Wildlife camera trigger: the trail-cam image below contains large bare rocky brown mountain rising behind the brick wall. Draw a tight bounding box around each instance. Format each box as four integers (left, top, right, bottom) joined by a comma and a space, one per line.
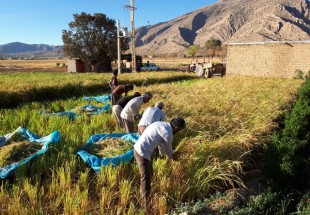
136, 0, 310, 55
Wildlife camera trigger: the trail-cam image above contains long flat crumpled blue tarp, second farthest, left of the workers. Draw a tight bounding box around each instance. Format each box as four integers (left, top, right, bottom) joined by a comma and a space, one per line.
40, 104, 110, 120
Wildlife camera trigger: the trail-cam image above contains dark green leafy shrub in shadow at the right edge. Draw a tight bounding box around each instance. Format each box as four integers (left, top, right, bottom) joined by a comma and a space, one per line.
264, 79, 310, 187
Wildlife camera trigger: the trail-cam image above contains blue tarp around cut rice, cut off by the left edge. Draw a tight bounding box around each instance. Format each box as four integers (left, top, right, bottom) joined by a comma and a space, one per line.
0, 127, 60, 179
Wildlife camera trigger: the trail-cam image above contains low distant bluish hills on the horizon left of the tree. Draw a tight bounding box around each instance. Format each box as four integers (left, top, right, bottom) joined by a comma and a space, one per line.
0, 42, 63, 57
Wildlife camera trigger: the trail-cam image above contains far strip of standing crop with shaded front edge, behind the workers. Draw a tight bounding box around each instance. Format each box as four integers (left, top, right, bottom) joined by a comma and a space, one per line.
0, 72, 196, 108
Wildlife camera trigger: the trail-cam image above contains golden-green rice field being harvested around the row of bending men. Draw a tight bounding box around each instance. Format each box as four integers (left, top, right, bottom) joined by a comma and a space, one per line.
0, 73, 302, 214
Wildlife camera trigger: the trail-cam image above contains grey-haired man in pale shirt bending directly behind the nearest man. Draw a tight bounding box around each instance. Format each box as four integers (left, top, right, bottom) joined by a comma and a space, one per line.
138, 102, 166, 135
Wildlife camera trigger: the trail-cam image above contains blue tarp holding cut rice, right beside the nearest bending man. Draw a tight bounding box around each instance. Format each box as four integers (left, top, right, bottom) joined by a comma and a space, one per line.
77, 133, 140, 172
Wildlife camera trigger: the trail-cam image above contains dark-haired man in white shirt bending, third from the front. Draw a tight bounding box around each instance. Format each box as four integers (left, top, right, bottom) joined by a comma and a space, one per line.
121, 92, 153, 133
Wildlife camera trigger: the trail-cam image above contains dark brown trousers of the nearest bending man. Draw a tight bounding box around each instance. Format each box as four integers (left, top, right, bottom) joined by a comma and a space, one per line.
134, 150, 153, 211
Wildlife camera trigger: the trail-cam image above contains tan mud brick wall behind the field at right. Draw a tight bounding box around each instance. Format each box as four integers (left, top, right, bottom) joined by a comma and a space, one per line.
226, 41, 310, 77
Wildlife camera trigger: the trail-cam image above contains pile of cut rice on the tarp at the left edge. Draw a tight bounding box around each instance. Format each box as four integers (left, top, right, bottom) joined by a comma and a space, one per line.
0, 140, 42, 167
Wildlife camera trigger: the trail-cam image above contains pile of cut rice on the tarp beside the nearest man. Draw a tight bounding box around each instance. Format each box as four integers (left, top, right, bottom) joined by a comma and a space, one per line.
87, 138, 133, 158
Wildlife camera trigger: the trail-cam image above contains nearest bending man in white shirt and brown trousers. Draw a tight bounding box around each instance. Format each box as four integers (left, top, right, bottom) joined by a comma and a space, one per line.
134, 117, 186, 212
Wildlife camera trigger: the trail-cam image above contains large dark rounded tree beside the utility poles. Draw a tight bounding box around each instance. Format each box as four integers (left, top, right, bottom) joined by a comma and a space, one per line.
62, 12, 128, 71
